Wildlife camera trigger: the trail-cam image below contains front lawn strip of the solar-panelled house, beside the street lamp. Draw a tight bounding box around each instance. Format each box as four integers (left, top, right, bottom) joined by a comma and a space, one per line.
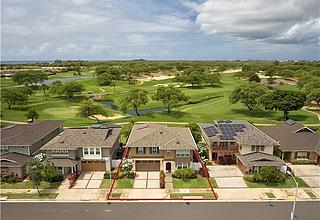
245, 177, 309, 188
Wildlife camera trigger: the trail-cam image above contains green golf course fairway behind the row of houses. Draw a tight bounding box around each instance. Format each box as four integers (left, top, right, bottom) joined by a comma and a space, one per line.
1, 70, 319, 127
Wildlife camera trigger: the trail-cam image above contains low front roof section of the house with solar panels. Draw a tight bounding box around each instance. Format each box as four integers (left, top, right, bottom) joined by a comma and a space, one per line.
236, 152, 285, 166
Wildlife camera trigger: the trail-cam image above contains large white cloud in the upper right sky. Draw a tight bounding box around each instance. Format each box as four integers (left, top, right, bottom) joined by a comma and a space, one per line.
191, 0, 319, 44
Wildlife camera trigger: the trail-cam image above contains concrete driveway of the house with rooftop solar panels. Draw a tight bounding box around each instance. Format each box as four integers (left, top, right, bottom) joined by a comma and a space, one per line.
207, 165, 247, 188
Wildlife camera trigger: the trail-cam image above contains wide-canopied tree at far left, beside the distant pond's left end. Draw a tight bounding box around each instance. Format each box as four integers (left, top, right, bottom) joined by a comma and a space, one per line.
12, 71, 48, 88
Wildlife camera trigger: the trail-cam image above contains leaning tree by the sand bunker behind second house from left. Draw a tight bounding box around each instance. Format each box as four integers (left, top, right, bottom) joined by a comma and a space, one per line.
79, 99, 107, 123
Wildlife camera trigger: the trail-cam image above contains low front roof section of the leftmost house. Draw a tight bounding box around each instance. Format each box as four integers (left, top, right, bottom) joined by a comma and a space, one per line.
0, 153, 32, 167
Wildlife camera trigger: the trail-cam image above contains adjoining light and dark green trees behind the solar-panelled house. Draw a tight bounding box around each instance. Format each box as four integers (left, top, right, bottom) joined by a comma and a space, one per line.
229, 82, 307, 120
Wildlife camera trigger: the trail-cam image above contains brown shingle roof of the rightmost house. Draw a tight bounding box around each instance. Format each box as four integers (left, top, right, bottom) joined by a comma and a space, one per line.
259, 120, 320, 152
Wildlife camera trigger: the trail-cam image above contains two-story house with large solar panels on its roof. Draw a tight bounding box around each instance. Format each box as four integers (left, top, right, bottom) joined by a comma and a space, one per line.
199, 120, 285, 173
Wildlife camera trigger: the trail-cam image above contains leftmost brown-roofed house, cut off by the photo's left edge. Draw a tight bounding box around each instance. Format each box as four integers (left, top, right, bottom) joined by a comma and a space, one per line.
0, 120, 63, 178
